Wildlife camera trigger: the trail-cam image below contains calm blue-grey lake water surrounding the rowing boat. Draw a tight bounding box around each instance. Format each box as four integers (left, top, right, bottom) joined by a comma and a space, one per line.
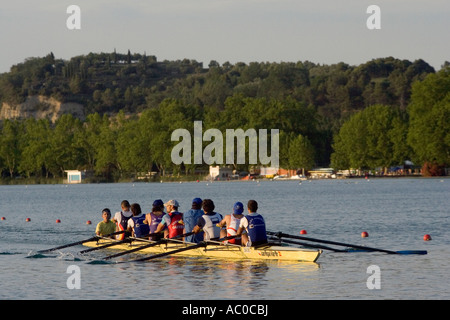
0, 179, 450, 300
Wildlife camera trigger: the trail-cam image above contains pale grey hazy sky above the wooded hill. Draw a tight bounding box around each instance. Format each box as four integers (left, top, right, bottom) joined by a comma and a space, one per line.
0, 0, 450, 73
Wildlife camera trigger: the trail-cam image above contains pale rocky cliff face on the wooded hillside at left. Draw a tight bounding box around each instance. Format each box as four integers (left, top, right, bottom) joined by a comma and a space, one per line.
0, 96, 85, 122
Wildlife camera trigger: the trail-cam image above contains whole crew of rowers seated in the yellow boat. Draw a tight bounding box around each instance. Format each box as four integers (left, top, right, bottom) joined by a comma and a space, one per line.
96, 198, 267, 247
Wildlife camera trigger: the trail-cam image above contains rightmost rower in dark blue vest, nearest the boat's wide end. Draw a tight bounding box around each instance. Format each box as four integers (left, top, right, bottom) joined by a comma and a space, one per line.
237, 200, 267, 247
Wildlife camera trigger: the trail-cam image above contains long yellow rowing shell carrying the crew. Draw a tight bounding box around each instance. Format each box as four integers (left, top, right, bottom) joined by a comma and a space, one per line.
83, 240, 322, 262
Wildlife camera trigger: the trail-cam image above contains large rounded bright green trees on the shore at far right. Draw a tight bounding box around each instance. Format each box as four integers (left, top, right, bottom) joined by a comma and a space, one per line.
331, 66, 450, 174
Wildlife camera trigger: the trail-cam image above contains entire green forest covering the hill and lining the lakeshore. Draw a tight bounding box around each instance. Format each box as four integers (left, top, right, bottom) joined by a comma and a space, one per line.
0, 50, 450, 181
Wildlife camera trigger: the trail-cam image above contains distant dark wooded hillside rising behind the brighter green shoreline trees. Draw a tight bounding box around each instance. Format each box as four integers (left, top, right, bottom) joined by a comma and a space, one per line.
0, 52, 435, 126
